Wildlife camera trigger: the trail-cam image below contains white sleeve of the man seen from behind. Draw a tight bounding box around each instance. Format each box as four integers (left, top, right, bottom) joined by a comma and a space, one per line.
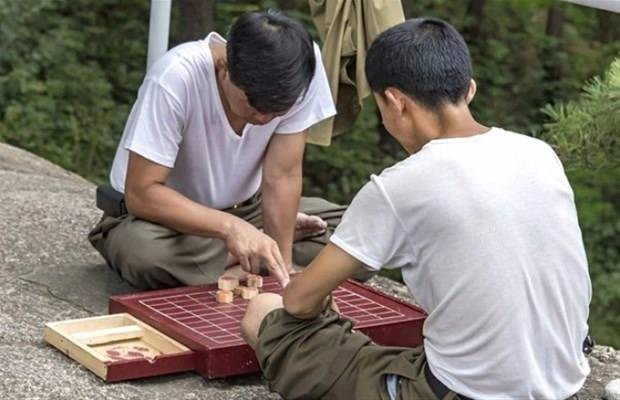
330, 175, 408, 270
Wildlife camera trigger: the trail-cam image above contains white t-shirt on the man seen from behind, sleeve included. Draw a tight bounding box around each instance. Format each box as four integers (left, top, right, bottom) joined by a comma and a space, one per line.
331, 128, 591, 400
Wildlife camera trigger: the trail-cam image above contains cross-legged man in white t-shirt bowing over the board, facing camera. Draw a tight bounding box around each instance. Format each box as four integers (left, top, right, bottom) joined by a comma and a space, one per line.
89, 12, 344, 288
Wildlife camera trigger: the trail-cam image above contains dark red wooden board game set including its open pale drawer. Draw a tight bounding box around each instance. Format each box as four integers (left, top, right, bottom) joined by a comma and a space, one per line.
44, 277, 425, 382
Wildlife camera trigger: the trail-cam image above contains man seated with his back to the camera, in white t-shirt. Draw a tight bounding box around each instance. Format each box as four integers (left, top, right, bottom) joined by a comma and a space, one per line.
241, 19, 591, 399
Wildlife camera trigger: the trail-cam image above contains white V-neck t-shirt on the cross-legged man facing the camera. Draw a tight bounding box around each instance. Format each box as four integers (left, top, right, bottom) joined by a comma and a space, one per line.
110, 32, 336, 209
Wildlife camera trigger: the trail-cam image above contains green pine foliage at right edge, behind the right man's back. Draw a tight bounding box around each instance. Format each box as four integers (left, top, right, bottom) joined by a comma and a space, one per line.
542, 59, 620, 347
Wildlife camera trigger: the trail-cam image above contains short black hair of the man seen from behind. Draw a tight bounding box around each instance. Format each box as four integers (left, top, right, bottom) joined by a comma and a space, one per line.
366, 18, 472, 110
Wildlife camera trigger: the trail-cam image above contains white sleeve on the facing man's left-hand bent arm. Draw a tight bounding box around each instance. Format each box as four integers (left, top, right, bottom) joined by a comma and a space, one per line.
123, 79, 184, 168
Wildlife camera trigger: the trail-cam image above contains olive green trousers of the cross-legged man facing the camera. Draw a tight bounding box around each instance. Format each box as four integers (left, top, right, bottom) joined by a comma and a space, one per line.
88, 196, 346, 289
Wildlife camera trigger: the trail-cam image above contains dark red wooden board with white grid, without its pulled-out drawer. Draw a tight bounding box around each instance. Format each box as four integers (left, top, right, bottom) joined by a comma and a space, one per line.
109, 277, 425, 378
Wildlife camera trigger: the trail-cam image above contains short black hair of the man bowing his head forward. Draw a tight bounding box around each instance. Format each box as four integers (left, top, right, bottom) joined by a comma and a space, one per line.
226, 10, 316, 113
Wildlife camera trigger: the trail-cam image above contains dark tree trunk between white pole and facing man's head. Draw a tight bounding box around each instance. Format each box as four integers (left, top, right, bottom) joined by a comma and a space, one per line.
174, 0, 215, 43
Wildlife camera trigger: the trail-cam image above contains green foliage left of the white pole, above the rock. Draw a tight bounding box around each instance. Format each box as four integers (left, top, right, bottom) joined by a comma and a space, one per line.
0, 0, 148, 181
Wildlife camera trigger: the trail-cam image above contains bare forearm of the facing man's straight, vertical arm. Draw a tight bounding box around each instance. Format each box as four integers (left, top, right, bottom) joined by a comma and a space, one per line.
262, 174, 302, 266
